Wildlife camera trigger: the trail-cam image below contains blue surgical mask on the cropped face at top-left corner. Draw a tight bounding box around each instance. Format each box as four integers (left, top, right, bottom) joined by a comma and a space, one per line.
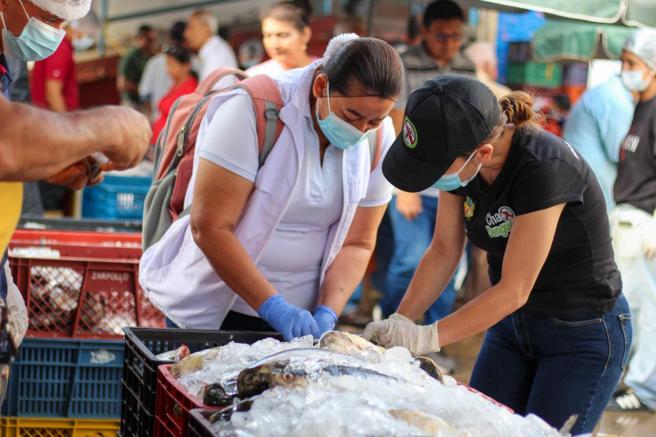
0, 0, 66, 61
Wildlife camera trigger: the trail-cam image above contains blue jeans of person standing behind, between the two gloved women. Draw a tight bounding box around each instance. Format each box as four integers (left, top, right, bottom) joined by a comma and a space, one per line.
380, 196, 456, 324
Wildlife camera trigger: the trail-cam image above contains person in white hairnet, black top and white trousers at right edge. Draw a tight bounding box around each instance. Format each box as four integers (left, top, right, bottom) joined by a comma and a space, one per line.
609, 29, 656, 411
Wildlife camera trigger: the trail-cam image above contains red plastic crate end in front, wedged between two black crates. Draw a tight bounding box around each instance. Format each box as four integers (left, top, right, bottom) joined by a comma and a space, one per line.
154, 364, 218, 437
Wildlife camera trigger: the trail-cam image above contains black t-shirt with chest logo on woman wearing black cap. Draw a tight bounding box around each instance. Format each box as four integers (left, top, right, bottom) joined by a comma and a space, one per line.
453, 127, 622, 318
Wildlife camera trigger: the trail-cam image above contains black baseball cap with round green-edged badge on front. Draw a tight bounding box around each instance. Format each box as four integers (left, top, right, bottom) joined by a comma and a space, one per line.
383, 74, 501, 192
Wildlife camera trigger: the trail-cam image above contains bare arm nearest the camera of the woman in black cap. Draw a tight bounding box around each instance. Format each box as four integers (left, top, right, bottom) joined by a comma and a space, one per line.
426, 204, 565, 346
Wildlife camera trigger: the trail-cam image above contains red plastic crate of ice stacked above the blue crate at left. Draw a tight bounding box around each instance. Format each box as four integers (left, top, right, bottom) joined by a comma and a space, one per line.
9, 230, 164, 338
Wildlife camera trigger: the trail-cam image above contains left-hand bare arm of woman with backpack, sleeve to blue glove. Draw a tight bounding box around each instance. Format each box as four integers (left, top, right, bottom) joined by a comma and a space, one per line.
191, 159, 276, 309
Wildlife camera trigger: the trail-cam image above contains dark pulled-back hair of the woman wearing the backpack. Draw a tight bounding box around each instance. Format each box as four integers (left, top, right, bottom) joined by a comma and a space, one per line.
323, 38, 403, 99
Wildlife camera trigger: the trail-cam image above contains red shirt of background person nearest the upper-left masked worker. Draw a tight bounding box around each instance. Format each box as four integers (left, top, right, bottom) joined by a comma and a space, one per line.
30, 38, 80, 111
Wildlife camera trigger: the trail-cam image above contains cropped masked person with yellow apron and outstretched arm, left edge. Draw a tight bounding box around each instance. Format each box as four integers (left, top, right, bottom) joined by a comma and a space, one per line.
0, 0, 150, 404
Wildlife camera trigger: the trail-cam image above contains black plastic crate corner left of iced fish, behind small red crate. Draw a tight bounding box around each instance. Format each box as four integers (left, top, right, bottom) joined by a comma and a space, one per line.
121, 328, 281, 437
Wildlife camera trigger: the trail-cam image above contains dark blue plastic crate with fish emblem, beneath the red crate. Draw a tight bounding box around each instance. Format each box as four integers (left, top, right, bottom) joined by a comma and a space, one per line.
2, 338, 124, 419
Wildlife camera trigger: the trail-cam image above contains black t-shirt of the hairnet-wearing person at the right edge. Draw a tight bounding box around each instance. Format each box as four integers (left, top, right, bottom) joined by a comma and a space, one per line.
614, 98, 656, 214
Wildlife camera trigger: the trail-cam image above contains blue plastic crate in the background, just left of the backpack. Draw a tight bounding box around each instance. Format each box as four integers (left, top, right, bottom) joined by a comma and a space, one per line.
82, 175, 151, 220
